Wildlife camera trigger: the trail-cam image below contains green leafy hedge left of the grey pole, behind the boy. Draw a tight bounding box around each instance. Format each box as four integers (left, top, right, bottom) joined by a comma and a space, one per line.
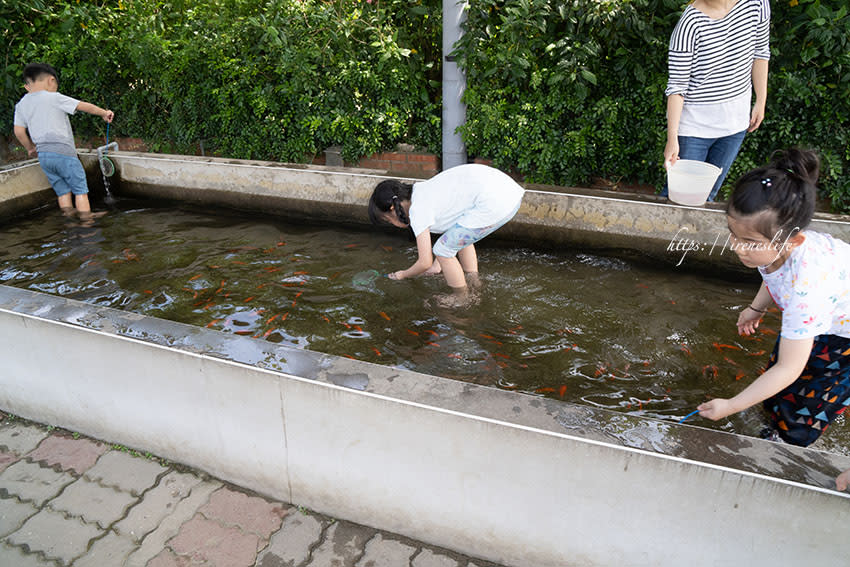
0, 0, 441, 161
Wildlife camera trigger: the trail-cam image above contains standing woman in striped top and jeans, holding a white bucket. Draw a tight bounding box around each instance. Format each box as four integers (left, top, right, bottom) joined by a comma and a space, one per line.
662, 0, 770, 201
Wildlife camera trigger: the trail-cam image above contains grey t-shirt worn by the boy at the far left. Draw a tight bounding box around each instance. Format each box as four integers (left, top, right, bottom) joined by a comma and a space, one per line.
15, 91, 80, 156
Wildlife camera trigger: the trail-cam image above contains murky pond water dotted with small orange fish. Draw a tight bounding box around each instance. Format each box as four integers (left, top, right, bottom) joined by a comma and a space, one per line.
0, 199, 850, 453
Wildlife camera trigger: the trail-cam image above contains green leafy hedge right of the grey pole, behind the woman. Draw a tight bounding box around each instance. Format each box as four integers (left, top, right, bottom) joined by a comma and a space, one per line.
456, 0, 850, 212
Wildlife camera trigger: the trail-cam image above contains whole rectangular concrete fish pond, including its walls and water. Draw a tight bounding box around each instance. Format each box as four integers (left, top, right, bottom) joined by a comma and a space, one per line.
0, 152, 850, 566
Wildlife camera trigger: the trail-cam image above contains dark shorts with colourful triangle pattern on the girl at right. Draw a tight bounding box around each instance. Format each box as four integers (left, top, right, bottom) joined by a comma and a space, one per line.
764, 335, 850, 447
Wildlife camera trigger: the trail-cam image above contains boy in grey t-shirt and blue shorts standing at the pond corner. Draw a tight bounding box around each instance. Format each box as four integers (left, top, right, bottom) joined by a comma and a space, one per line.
15, 63, 114, 219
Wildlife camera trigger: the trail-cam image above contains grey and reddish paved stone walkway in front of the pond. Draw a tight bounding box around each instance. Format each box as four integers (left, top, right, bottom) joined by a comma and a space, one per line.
0, 413, 504, 567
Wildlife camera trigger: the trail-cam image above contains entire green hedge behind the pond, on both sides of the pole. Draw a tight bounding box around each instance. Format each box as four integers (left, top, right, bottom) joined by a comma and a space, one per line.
0, 0, 850, 212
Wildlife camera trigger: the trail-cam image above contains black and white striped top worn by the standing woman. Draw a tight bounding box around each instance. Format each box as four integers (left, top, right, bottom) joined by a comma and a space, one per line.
665, 0, 770, 105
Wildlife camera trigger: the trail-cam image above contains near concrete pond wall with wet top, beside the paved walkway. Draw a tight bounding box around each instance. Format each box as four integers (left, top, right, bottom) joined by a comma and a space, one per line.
0, 286, 850, 567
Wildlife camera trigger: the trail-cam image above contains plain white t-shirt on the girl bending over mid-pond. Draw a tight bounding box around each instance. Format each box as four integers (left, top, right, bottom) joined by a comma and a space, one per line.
409, 163, 525, 236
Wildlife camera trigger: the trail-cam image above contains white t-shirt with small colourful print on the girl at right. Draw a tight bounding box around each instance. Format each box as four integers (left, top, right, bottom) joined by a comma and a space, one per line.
759, 231, 850, 339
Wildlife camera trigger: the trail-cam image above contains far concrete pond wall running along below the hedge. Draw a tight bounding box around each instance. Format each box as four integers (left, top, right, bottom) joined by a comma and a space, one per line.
73, 152, 850, 273
